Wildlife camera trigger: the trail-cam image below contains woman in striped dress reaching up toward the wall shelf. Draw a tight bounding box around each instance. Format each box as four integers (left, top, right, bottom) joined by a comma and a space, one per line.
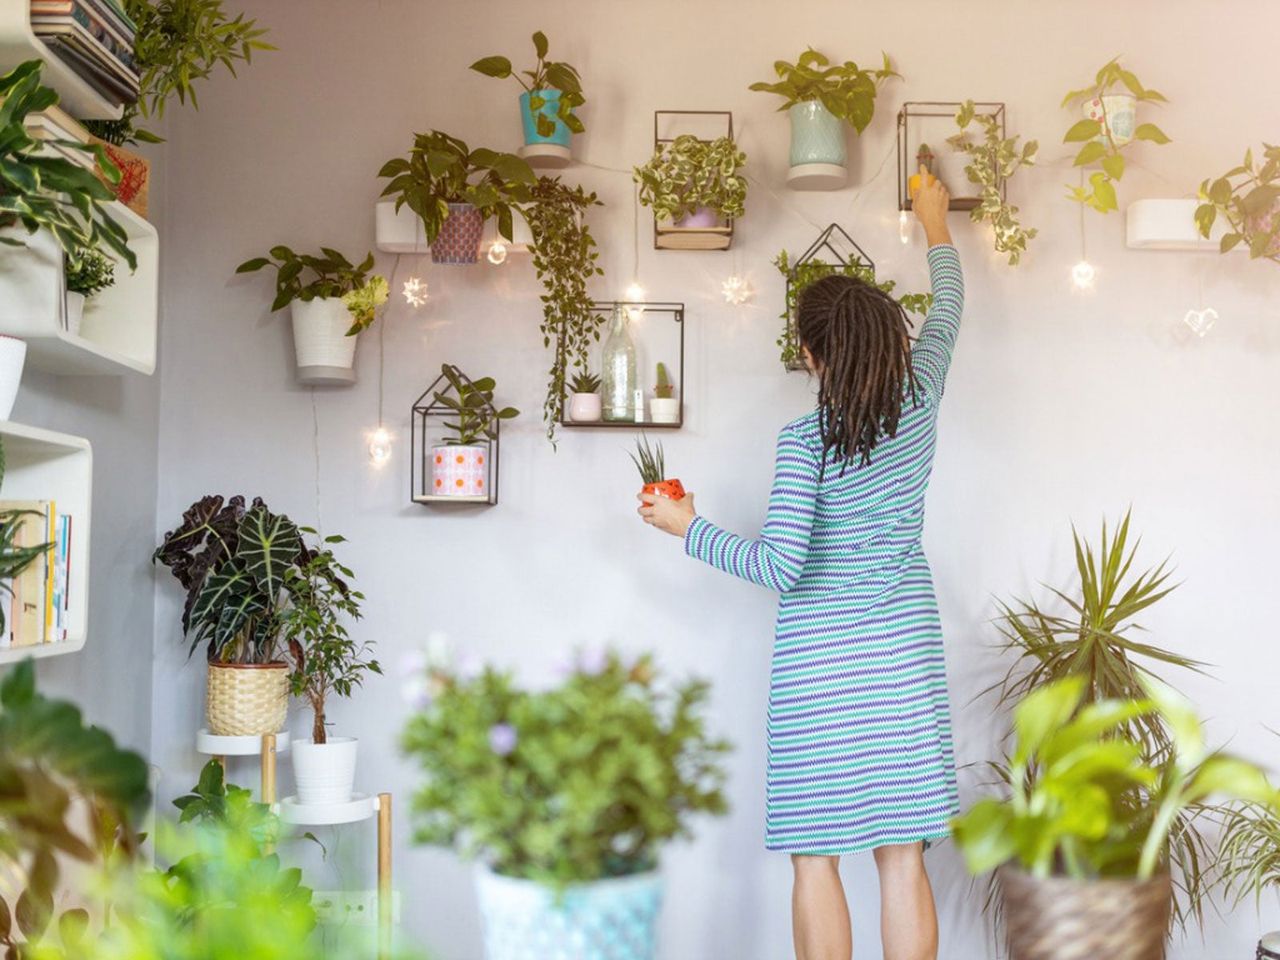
640, 178, 964, 960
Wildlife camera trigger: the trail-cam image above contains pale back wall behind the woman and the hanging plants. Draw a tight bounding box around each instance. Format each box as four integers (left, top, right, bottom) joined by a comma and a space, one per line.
147, 0, 1280, 960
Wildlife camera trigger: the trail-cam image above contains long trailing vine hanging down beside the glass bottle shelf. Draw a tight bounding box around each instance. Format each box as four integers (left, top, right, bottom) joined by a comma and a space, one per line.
525, 177, 604, 447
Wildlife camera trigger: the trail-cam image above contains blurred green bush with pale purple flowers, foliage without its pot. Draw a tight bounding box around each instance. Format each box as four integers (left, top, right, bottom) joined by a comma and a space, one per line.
403, 653, 730, 887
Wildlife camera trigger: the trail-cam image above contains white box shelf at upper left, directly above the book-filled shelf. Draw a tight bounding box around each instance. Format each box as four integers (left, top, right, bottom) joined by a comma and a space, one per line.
0, 200, 160, 375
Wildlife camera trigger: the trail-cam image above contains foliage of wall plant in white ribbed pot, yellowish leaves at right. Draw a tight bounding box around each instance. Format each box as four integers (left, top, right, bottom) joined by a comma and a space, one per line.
236, 244, 389, 337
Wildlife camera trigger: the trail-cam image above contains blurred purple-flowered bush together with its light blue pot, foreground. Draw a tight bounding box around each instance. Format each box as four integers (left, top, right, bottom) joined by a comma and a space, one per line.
403, 652, 728, 960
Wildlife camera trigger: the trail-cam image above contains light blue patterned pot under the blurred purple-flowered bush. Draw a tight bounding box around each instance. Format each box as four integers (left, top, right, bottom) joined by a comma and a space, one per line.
476, 867, 662, 960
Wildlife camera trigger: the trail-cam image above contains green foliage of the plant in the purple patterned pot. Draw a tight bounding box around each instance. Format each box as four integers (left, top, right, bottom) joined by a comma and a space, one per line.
378, 131, 538, 243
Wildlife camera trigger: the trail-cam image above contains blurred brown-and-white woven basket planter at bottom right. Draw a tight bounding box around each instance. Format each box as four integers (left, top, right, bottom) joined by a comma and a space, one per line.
998, 867, 1172, 960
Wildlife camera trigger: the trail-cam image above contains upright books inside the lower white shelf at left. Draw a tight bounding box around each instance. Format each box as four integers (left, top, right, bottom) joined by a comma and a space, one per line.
0, 500, 72, 649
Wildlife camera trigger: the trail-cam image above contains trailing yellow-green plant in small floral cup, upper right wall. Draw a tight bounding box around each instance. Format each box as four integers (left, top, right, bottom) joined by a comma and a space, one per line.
1062, 58, 1169, 214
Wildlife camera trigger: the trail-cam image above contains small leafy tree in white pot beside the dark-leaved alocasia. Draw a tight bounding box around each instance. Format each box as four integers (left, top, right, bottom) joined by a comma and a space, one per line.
280, 537, 383, 804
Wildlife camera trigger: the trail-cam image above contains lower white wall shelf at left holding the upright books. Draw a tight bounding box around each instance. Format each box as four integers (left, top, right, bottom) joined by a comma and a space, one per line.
0, 420, 93, 663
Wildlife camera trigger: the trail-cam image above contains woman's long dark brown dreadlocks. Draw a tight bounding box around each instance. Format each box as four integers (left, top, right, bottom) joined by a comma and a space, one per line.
796, 275, 916, 474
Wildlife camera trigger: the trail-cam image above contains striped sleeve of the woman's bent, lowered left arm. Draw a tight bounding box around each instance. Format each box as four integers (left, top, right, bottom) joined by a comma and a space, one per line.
685, 428, 818, 593
